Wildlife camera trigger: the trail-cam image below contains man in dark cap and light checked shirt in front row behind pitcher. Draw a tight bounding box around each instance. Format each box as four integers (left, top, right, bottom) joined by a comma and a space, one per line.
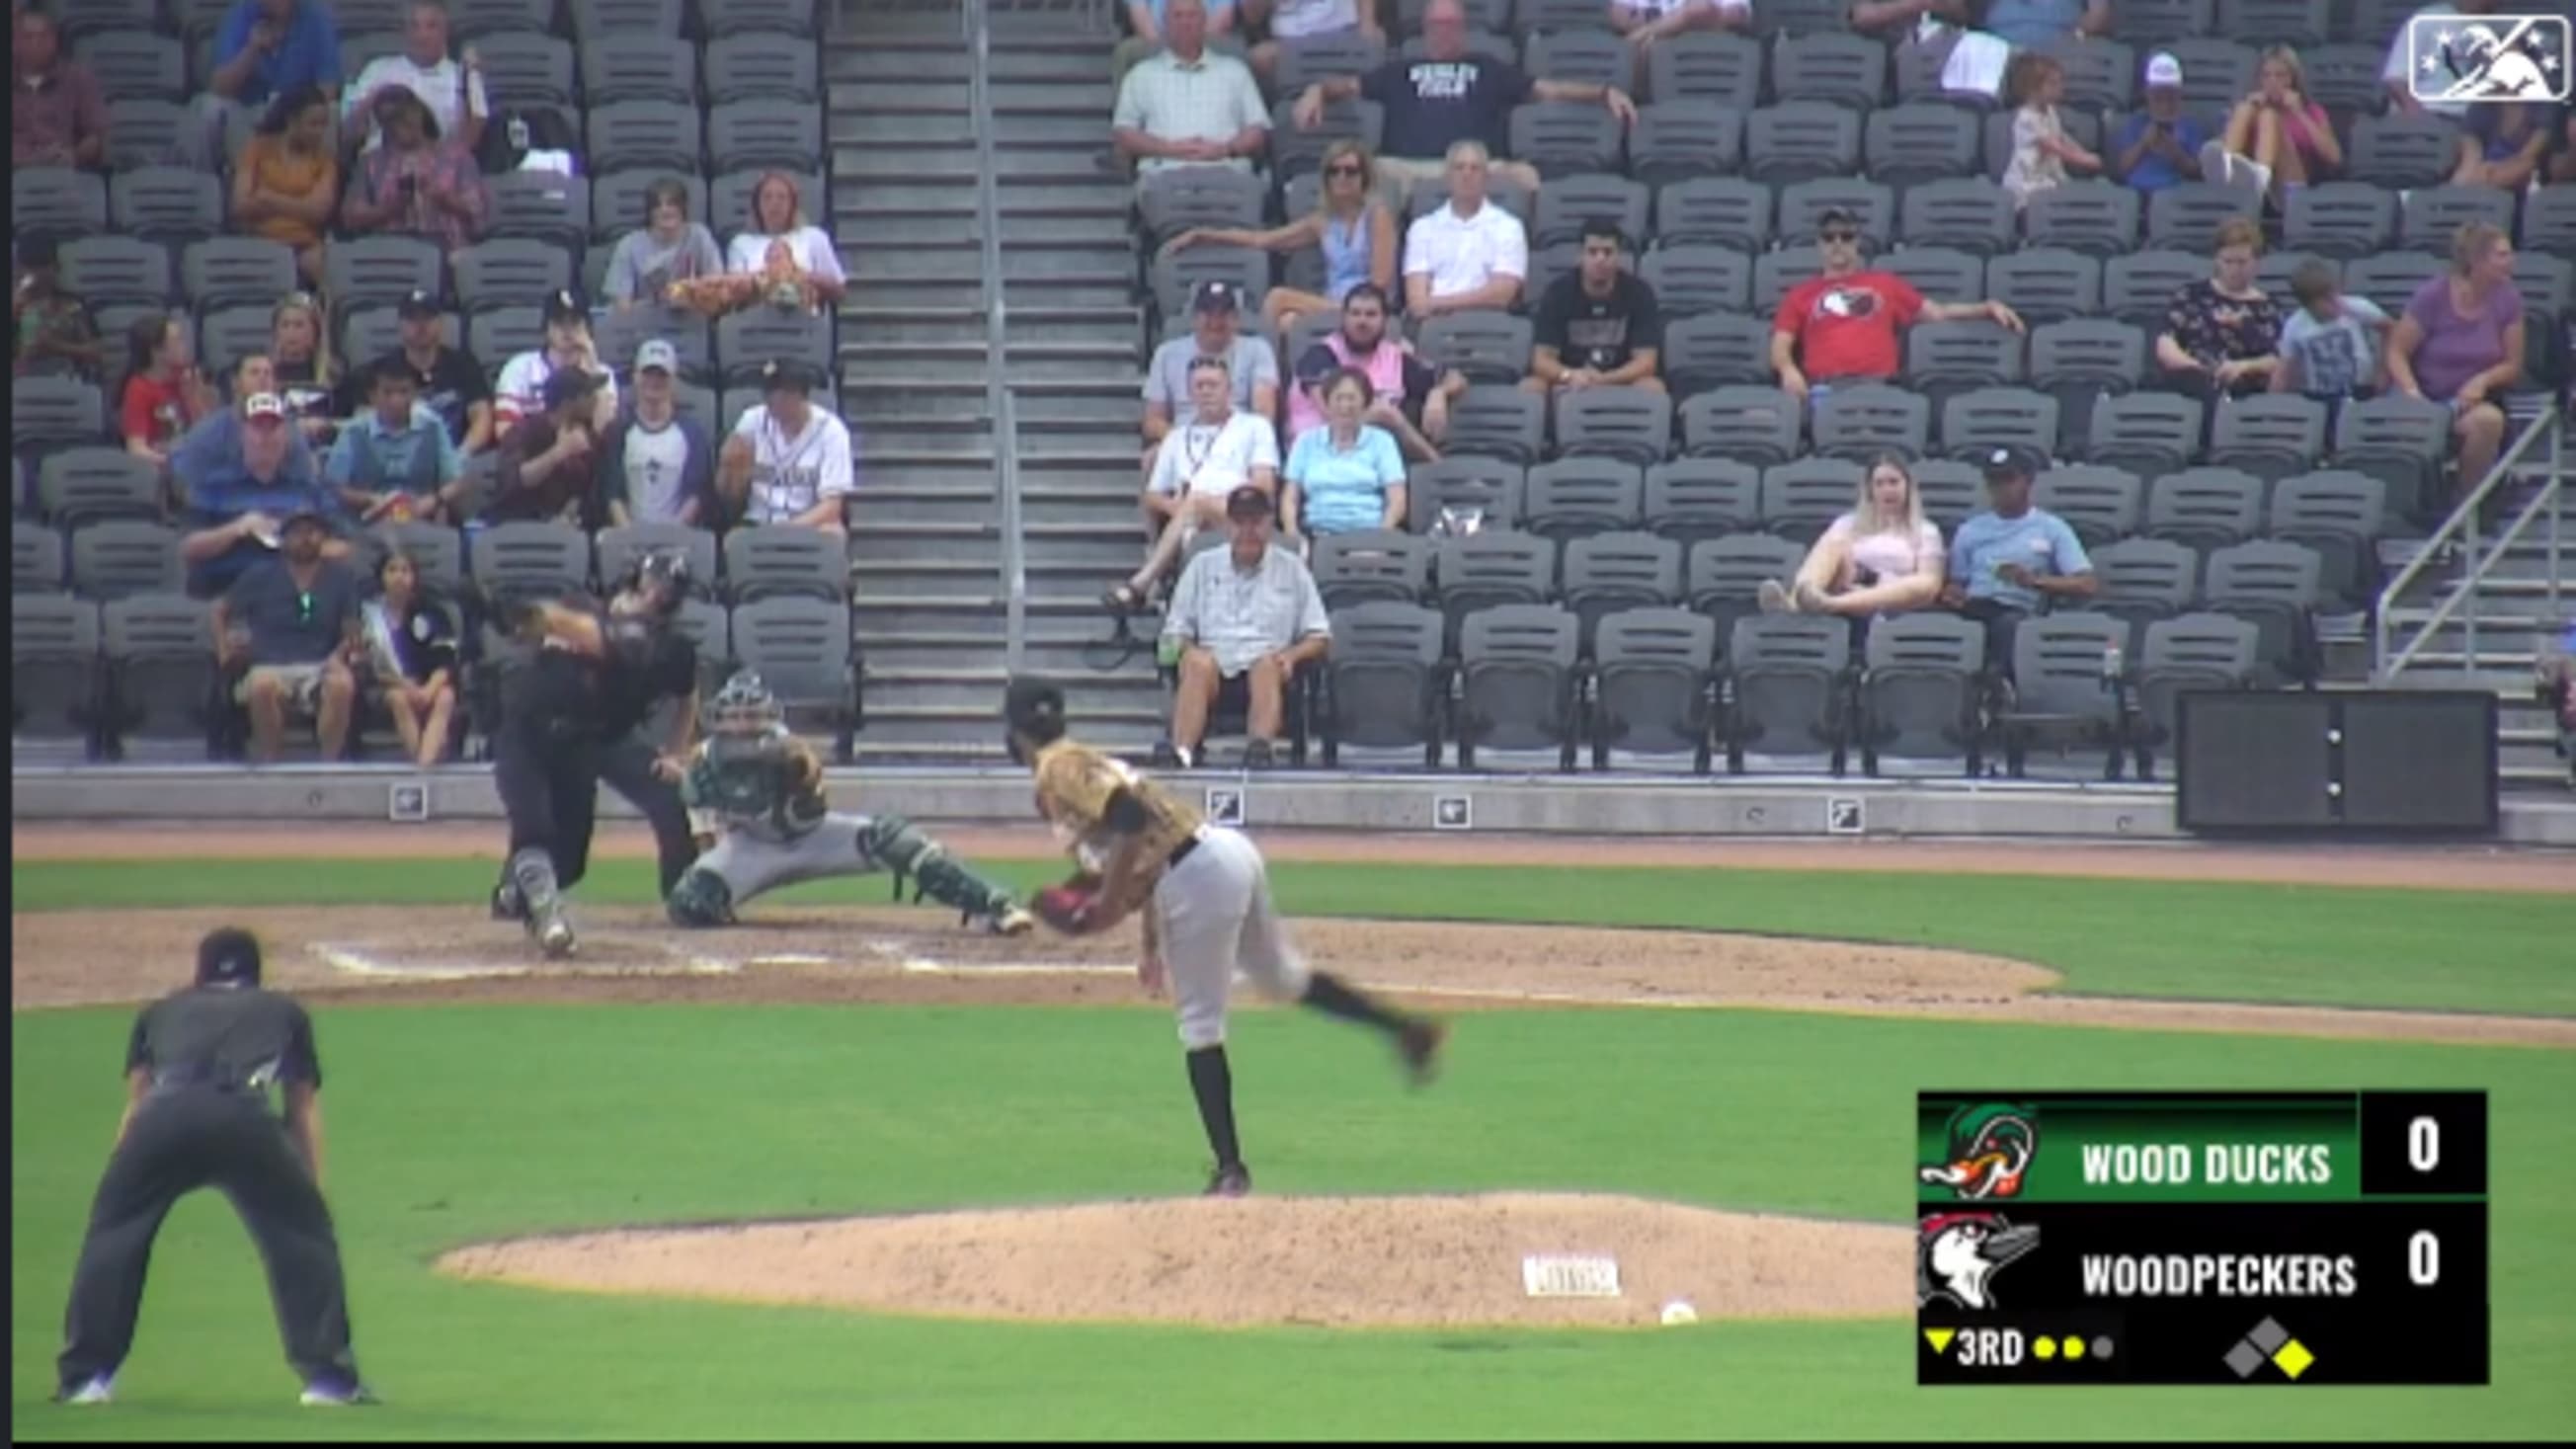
1157, 482, 1331, 768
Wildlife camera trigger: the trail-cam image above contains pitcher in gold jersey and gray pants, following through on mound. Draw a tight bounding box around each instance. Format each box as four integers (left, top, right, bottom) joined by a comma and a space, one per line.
1003, 679, 1448, 1196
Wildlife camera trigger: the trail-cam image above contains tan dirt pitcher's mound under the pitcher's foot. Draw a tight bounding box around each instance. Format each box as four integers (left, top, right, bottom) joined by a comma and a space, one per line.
438, 1194, 1914, 1328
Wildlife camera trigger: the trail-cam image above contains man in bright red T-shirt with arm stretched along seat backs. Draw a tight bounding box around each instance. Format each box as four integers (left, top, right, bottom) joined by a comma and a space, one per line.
1772, 206, 2022, 402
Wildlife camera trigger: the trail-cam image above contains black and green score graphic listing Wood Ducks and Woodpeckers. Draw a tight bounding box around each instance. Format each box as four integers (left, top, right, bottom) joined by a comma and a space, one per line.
1914, 1090, 2488, 1387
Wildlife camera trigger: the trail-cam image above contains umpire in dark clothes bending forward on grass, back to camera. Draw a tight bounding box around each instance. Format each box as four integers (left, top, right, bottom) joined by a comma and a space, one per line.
54, 928, 371, 1406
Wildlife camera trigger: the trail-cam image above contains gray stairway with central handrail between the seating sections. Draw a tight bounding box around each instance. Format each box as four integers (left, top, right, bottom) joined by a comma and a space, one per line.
825, 5, 1160, 758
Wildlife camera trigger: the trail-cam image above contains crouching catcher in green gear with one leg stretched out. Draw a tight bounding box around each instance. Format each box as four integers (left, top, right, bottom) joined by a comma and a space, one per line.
667, 671, 1035, 936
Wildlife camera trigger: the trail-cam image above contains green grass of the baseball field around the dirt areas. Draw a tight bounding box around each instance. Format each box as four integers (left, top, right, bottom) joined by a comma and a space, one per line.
10, 861, 2576, 1441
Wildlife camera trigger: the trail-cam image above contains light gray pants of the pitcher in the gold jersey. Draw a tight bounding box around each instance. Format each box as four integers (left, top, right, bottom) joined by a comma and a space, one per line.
1152, 825, 1306, 1052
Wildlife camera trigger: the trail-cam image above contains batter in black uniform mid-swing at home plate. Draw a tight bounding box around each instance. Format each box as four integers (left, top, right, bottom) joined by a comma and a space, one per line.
492, 552, 698, 956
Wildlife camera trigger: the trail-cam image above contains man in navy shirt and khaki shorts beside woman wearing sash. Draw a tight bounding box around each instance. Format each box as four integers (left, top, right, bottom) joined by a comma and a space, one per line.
213, 495, 365, 764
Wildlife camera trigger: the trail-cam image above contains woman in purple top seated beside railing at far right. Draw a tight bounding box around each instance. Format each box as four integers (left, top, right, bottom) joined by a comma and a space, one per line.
2388, 221, 2525, 503
